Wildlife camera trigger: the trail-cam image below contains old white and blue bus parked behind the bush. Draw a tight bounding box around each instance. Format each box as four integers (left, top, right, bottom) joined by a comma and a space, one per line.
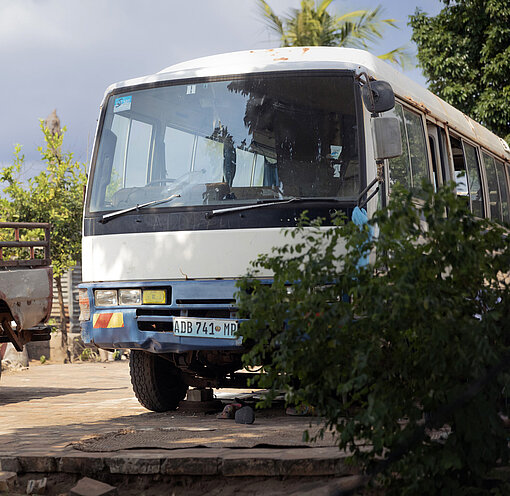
80, 47, 510, 411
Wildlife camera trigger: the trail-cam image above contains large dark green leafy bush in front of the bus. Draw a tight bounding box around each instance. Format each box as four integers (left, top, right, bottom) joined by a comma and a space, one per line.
238, 184, 510, 496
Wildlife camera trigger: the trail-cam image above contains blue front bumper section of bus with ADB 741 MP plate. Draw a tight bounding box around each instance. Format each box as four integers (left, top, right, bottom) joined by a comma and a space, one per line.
79, 280, 247, 353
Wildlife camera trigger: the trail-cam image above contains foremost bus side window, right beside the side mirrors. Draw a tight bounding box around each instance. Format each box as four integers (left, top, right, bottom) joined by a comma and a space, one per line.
389, 103, 429, 195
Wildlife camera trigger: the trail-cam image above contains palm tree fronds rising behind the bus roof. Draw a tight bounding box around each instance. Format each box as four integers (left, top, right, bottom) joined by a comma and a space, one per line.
258, 0, 409, 66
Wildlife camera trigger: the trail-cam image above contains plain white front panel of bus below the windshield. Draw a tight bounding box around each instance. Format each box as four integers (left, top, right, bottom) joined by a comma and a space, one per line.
83, 228, 291, 282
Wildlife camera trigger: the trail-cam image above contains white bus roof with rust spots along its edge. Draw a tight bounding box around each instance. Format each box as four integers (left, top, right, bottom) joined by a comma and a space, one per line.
106, 47, 510, 160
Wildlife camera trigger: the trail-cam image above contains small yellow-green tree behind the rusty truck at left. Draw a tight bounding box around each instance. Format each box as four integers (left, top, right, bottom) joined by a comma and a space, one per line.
0, 121, 86, 347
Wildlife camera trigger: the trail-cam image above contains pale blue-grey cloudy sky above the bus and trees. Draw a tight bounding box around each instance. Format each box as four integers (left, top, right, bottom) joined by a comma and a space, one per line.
0, 0, 442, 177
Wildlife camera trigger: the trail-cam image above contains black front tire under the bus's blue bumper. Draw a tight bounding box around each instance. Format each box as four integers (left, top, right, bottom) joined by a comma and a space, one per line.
129, 350, 188, 412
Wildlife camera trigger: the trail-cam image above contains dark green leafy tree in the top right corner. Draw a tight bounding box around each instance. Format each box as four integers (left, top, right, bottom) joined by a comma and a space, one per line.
409, 0, 510, 143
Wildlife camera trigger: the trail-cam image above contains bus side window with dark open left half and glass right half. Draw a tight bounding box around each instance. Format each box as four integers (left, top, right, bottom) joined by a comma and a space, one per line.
450, 136, 484, 217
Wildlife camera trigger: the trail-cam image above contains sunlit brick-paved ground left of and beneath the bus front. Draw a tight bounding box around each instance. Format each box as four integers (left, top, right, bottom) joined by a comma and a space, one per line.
0, 360, 331, 453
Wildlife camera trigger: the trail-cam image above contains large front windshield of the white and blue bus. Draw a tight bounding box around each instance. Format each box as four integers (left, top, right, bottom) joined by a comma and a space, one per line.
89, 72, 360, 212
